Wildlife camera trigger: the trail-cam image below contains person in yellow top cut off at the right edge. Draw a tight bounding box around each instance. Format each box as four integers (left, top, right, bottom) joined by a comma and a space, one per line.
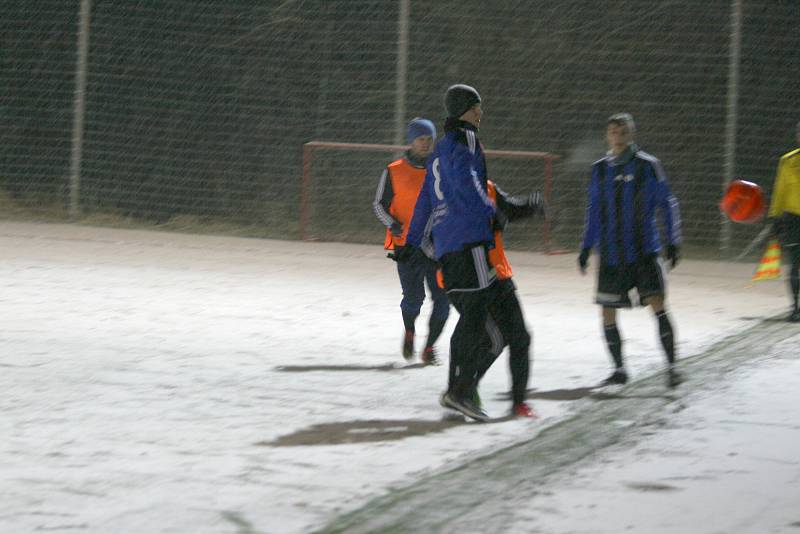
767, 122, 800, 323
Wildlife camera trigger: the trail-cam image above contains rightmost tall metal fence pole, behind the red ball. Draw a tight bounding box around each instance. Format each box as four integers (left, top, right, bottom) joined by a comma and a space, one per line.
719, 0, 742, 259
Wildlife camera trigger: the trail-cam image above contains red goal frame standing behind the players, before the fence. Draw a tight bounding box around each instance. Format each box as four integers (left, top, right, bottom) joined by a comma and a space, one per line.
300, 141, 560, 254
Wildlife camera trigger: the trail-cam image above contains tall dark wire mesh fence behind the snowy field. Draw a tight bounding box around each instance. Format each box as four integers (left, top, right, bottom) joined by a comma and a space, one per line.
0, 0, 800, 255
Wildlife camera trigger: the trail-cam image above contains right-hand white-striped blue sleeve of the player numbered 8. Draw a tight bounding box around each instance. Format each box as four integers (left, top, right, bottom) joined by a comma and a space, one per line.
453, 140, 495, 220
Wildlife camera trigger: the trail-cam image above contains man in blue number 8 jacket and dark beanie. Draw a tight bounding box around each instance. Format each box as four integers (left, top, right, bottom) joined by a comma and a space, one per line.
401, 84, 497, 420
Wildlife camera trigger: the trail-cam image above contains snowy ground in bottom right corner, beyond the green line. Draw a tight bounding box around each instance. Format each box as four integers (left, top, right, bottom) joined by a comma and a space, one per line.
504, 348, 800, 534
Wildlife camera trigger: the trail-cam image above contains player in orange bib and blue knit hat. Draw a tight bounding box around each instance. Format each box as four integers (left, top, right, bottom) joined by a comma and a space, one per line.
372, 118, 450, 364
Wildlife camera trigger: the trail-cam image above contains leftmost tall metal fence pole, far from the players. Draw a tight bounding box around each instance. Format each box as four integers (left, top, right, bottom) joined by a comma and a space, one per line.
69, 0, 92, 222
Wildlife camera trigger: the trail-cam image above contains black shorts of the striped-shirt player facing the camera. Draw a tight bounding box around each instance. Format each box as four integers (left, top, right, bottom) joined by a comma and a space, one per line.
595, 255, 666, 308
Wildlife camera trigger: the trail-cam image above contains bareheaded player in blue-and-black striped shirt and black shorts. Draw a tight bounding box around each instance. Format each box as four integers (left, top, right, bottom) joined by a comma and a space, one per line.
578, 113, 682, 387
